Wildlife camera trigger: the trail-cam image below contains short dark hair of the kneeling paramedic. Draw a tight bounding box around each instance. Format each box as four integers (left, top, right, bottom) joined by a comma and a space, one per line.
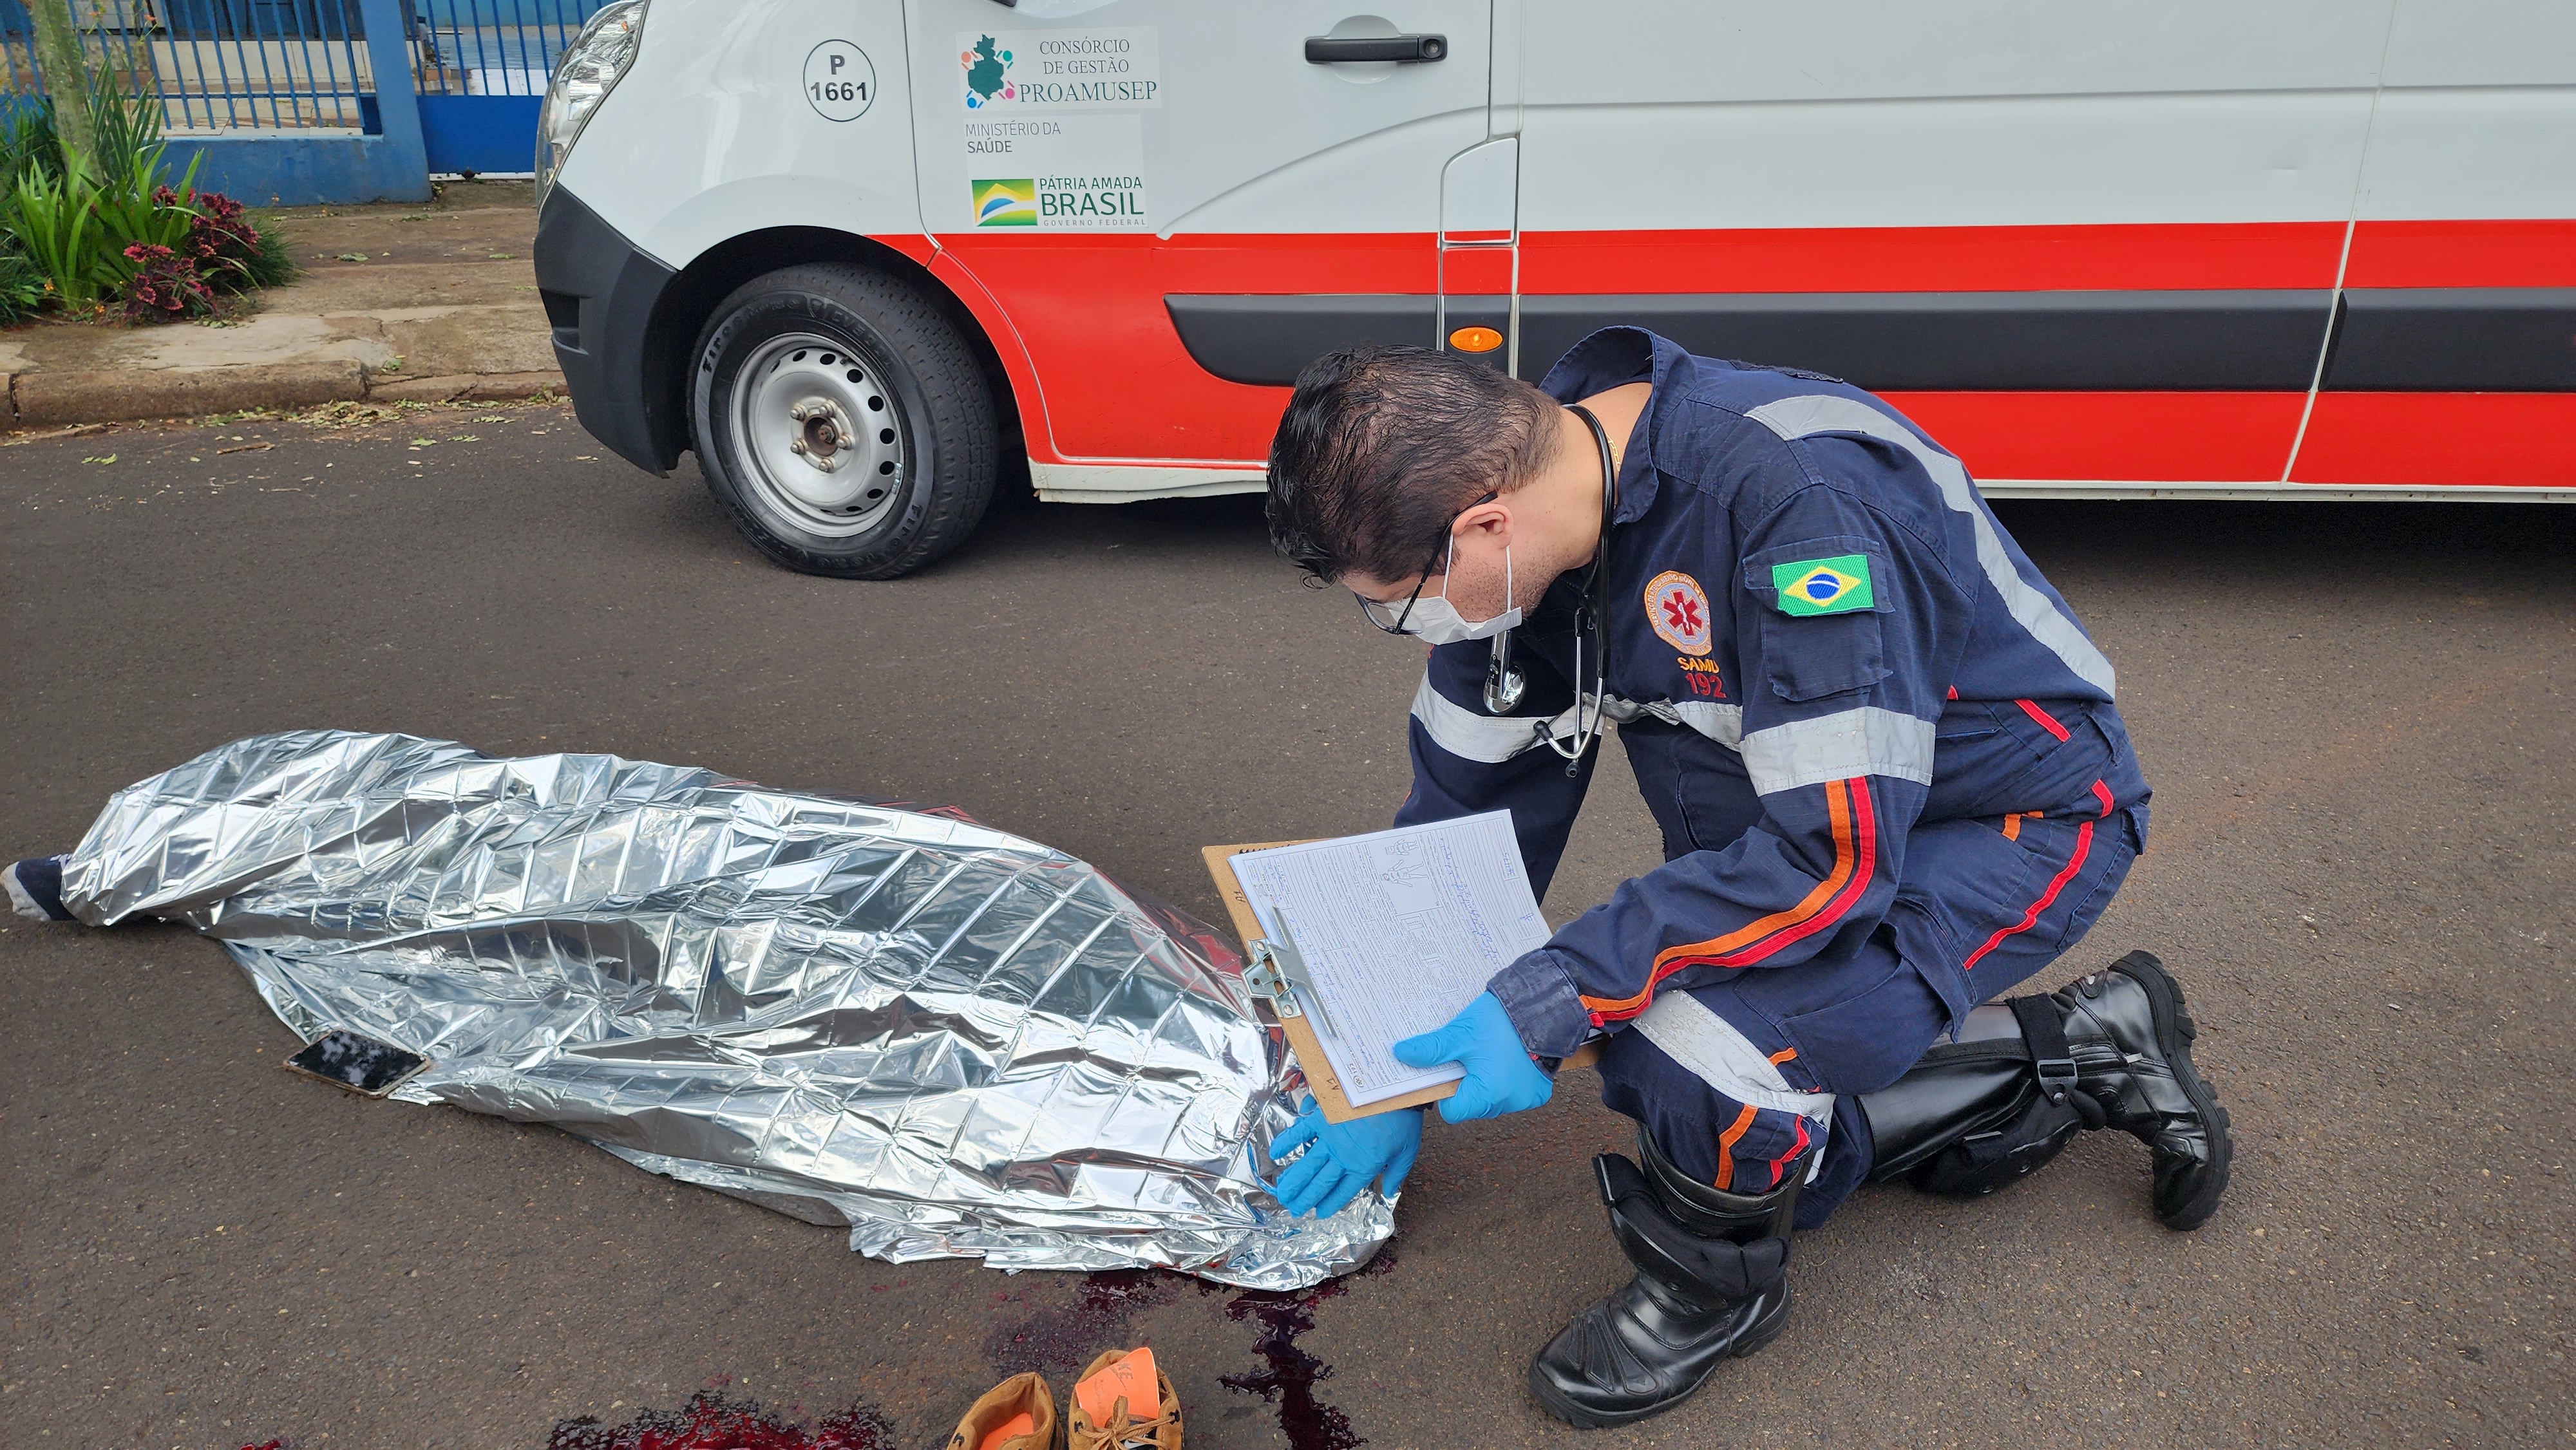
1267, 348, 1556, 582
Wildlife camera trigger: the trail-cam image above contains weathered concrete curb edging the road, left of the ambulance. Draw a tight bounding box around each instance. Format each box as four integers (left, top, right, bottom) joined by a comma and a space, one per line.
0, 358, 564, 430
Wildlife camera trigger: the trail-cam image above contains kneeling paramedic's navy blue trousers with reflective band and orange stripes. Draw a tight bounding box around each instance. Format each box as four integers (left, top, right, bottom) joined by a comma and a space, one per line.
1600, 721, 2146, 1229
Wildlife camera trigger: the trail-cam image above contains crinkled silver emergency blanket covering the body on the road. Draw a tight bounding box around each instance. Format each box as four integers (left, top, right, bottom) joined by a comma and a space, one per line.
62, 731, 1394, 1288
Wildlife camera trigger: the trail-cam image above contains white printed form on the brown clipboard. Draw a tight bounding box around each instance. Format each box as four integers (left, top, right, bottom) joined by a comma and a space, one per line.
1226, 811, 1548, 1107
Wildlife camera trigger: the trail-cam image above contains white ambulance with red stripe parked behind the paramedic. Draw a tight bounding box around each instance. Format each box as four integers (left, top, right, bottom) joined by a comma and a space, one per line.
536, 0, 2576, 577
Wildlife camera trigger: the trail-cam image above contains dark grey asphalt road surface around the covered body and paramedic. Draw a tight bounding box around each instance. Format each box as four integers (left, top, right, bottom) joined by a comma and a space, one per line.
0, 407, 2576, 1450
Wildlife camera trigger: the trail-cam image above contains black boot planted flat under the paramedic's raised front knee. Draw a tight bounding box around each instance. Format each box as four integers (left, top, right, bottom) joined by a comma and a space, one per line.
1530, 1133, 1814, 1429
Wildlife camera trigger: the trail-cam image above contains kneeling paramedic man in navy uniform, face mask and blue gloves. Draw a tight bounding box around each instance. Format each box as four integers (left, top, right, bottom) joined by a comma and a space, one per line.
1270, 327, 2231, 1427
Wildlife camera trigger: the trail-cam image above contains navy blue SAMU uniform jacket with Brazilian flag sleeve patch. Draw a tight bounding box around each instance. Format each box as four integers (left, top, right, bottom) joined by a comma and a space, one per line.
1396, 327, 2146, 1056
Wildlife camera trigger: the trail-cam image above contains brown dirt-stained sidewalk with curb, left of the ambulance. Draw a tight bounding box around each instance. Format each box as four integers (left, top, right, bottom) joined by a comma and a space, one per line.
0, 180, 564, 430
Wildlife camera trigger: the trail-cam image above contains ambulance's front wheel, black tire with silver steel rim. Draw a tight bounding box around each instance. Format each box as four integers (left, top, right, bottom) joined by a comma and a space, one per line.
690, 263, 1002, 579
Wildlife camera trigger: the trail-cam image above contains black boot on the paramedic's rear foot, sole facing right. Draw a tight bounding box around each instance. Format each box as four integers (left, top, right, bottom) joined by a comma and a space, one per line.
1860, 950, 2233, 1229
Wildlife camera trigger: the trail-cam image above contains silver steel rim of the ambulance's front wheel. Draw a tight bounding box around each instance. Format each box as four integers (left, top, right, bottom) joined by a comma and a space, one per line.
732, 332, 909, 538
